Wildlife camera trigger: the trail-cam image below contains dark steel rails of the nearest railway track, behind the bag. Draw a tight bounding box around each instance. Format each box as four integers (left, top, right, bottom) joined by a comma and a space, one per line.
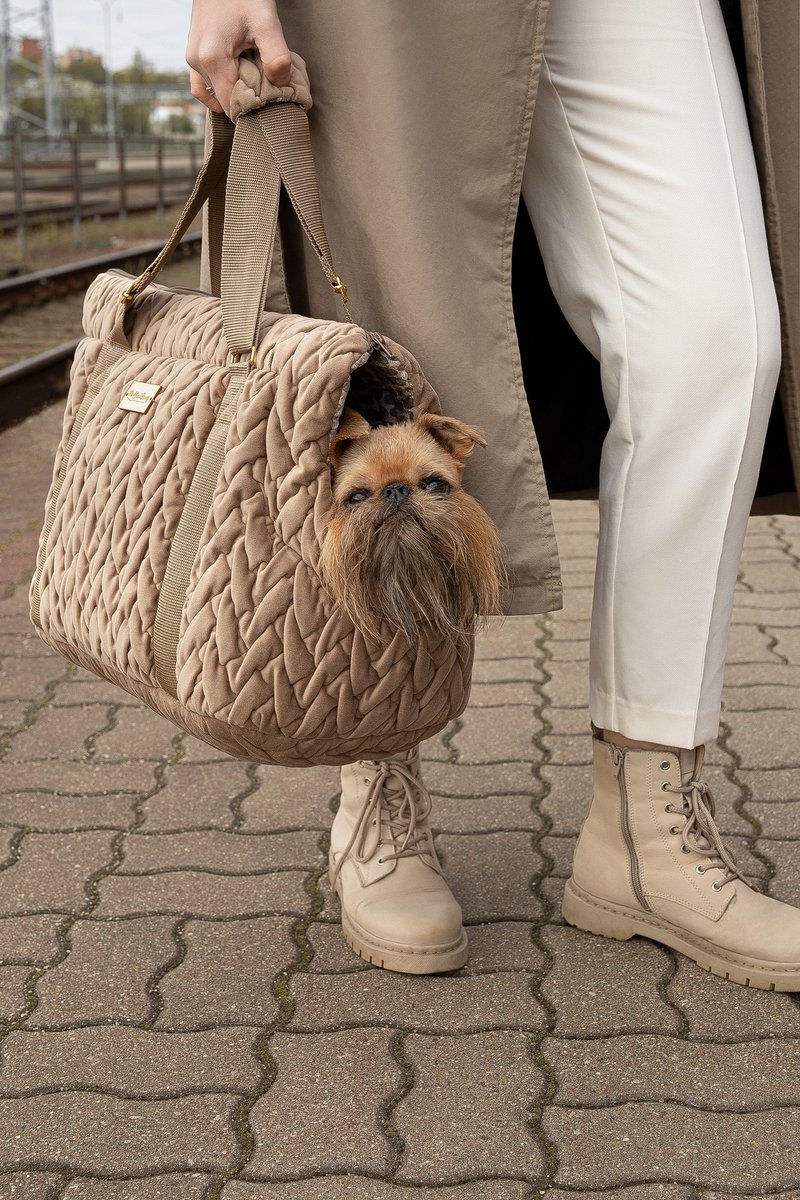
0, 233, 200, 428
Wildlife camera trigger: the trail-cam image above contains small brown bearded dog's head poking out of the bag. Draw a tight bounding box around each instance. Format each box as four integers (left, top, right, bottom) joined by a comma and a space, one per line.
320, 408, 506, 644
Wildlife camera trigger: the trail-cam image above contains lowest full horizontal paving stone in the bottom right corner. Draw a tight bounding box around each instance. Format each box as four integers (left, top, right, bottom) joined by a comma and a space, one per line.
542, 1103, 800, 1188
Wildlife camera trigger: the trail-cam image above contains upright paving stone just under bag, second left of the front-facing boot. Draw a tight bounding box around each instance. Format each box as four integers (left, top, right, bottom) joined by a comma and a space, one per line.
142, 762, 251, 833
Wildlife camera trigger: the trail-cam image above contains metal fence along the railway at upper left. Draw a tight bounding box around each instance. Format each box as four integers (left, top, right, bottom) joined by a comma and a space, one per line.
0, 134, 203, 256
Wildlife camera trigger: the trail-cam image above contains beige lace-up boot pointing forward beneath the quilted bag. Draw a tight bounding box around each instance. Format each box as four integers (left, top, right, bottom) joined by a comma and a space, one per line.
329, 749, 468, 974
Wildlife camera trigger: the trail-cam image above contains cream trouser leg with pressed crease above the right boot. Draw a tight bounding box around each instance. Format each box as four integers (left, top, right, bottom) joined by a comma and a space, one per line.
523, 0, 781, 746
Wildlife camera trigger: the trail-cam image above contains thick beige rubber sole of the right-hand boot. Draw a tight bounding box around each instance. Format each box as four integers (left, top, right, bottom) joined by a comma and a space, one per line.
561, 880, 800, 991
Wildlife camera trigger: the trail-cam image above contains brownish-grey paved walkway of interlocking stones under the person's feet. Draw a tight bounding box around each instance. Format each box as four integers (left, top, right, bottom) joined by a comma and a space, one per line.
0, 410, 800, 1200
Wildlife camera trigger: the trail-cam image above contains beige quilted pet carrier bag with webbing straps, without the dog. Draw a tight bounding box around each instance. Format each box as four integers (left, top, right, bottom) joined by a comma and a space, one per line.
31, 55, 473, 767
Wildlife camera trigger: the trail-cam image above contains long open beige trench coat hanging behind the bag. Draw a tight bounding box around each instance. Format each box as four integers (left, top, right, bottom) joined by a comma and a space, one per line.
201, 0, 800, 613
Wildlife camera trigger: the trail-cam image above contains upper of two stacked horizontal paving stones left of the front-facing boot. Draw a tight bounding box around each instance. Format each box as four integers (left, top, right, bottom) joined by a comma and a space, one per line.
118, 829, 319, 875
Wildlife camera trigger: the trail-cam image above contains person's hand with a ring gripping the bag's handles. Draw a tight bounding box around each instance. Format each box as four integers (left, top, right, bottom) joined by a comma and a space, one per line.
186, 0, 291, 116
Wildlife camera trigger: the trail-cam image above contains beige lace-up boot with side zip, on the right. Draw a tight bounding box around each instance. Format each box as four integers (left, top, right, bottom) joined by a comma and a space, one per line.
563, 736, 800, 991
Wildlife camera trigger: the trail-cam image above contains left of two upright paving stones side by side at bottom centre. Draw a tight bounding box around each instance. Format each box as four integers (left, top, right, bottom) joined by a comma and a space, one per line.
243, 1028, 403, 1181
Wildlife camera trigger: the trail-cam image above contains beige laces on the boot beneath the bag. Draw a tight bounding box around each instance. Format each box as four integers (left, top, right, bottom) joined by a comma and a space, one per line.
331, 760, 443, 884
